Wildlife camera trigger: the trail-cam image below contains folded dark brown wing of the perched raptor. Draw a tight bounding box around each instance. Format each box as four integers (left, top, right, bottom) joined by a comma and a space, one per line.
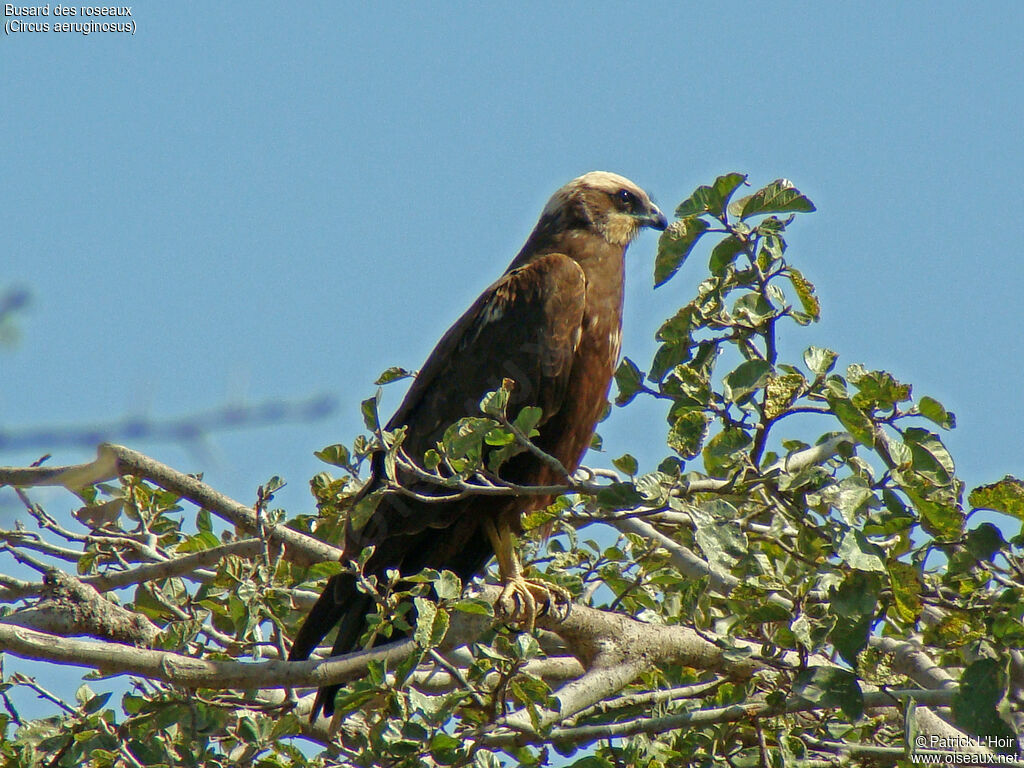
346, 254, 587, 540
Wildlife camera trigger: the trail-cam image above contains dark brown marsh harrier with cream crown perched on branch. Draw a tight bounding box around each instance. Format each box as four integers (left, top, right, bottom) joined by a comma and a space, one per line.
289, 171, 667, 719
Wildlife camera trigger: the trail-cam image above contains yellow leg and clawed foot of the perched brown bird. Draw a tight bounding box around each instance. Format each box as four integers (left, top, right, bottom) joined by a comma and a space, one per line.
483, 519, 572, 632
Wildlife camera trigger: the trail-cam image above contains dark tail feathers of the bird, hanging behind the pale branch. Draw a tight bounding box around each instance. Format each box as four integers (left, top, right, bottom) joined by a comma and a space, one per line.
288, 573, 373, 722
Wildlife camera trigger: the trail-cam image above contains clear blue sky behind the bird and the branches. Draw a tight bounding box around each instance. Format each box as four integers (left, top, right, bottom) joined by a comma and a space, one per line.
0, 1, 1024, 733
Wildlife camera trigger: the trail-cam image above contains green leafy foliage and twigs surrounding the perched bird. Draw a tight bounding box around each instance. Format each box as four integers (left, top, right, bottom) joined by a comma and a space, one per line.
0, 173, 1024, 768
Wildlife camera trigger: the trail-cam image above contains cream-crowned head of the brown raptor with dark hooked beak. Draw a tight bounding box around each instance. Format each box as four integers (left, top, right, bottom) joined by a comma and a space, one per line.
541, 171, 669, 248
